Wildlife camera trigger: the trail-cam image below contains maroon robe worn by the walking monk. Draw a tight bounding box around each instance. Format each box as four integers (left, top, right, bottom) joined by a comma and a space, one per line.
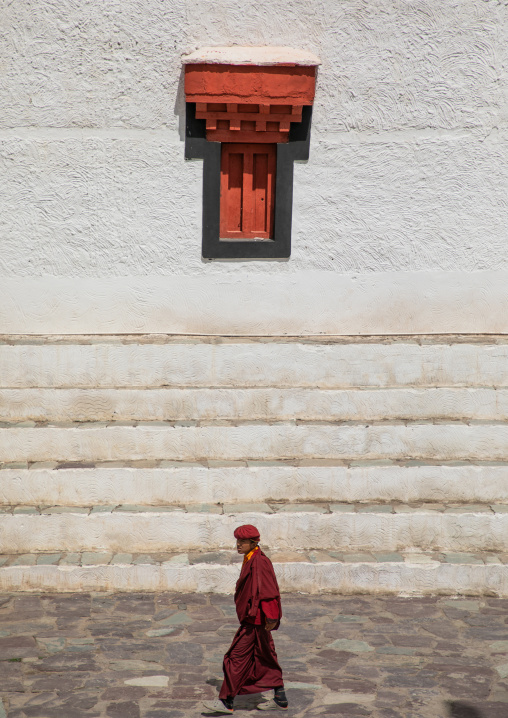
219, 549, 284, 698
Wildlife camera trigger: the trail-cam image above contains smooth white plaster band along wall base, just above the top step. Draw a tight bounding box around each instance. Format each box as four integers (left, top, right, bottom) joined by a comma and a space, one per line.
0, 272, 508, 336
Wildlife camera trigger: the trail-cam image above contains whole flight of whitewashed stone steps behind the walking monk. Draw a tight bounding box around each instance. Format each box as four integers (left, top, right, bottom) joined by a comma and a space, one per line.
0, 335, 508, 596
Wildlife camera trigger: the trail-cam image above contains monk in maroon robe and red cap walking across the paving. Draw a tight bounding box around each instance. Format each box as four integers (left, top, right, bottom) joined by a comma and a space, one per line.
204, 524, 288, 714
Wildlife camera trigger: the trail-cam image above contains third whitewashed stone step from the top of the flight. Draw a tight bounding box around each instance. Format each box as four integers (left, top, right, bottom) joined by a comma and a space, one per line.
0, 423, 508, 463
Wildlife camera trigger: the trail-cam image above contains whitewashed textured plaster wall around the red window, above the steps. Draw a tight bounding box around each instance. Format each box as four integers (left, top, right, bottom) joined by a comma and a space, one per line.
0, 0, 508, 334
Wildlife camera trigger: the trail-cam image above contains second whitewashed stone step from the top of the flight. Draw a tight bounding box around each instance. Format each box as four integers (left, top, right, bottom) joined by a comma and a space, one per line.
4, 387, 508, 423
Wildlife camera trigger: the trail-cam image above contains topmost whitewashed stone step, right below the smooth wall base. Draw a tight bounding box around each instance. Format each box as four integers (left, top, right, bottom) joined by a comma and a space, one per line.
0, 337, 508, 389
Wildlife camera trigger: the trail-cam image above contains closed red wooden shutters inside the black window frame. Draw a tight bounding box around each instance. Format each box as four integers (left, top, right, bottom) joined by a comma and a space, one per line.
220, 142, 277, 239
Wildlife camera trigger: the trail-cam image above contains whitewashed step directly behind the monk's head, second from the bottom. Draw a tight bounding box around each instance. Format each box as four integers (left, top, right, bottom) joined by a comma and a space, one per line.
0, 504, 508, 554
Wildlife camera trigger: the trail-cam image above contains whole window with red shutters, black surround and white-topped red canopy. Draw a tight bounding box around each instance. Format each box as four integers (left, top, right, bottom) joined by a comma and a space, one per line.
184, 50, 320, 260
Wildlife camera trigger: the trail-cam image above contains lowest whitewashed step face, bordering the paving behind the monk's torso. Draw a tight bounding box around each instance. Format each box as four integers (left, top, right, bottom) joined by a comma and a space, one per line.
0, 563, 508, 598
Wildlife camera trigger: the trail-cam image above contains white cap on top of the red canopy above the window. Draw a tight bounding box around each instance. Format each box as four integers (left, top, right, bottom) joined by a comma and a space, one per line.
182, 45, 321, 66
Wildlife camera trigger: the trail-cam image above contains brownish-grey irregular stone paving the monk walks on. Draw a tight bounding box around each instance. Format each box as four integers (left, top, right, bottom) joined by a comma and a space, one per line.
0, 593, 508, 718
